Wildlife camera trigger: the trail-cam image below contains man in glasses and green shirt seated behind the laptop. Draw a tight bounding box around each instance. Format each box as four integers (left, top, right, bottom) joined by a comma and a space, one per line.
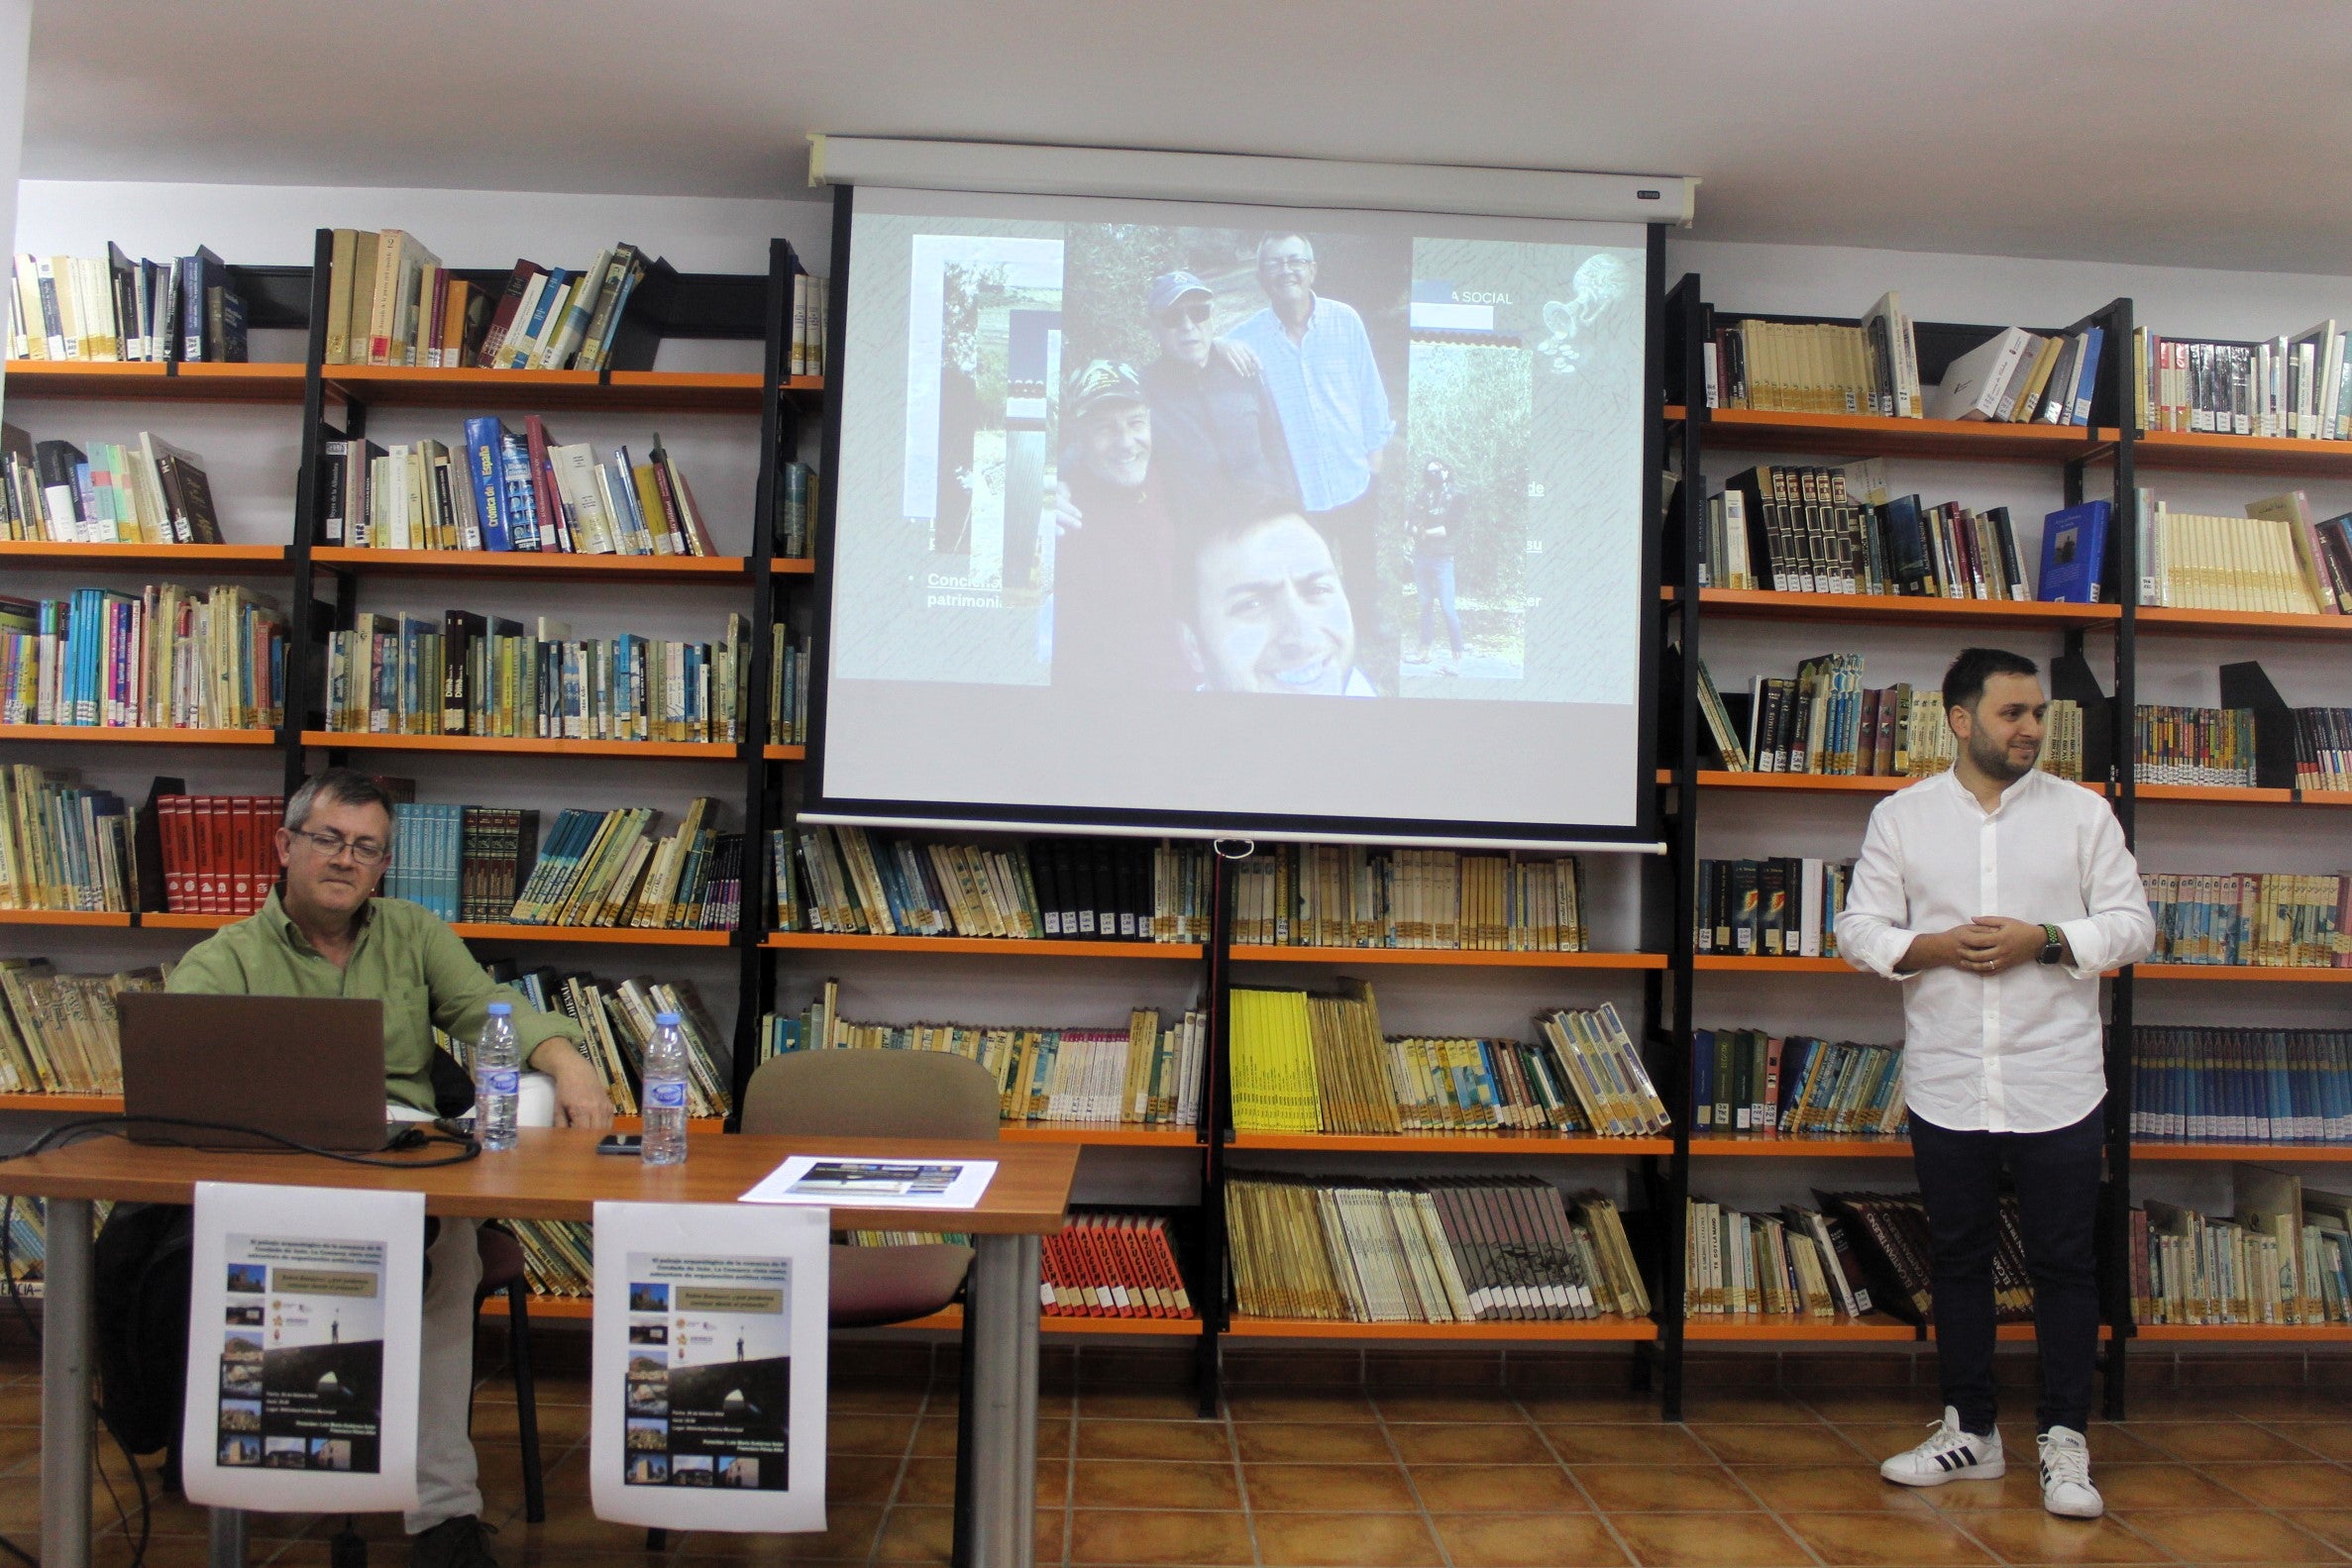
164, 769, 611, 1568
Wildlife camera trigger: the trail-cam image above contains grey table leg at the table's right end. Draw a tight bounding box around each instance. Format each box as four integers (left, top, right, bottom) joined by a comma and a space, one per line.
964, 1236, 1042, 1568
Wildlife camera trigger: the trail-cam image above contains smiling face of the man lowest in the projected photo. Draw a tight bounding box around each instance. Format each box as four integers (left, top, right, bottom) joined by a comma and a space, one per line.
1176, 501, 1378, 696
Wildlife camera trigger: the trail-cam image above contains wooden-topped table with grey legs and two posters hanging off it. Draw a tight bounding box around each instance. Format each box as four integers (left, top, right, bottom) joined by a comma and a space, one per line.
0, 1128, 1077, 1568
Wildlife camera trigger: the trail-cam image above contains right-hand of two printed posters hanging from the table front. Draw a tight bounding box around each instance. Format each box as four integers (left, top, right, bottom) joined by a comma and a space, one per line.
588, 1203, 830, 1530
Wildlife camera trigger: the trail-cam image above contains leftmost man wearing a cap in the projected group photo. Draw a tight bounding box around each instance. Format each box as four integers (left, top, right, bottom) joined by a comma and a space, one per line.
1054, 360, 1190, 691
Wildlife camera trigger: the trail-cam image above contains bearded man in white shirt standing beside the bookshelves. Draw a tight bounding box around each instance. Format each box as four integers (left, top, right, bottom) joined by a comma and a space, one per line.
1837, 649, 2157, 1518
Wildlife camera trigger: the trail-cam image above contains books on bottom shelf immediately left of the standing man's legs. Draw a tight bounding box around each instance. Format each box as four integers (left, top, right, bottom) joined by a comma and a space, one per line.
1681, 1197, 1870, 1318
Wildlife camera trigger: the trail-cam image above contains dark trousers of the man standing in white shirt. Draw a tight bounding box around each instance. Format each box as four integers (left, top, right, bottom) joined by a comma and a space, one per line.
1912, 1104, 2105, 1434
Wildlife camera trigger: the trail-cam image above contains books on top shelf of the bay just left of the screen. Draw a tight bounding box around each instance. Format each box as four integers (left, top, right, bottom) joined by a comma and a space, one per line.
327, 228, 671, 369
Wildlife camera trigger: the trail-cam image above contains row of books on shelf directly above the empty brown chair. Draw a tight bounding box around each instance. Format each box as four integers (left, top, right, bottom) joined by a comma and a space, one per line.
760, 981, 1209, 1126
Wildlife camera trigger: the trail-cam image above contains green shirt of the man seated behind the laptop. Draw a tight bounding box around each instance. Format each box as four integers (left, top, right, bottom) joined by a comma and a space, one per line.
164, 893, 581, 1112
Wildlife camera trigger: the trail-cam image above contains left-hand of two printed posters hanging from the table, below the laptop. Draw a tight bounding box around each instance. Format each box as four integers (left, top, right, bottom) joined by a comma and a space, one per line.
181, 1183, 426, 1514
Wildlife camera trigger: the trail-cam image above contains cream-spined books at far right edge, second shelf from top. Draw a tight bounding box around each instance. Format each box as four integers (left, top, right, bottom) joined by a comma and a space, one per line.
2138, 489, 2352, 616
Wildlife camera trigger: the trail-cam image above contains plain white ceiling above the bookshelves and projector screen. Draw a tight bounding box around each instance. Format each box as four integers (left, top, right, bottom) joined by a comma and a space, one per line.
24, 0, 2352, 272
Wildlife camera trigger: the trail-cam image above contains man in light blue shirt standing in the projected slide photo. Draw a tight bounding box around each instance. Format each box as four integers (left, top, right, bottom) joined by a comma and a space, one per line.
1232, 235, 1397, 621
